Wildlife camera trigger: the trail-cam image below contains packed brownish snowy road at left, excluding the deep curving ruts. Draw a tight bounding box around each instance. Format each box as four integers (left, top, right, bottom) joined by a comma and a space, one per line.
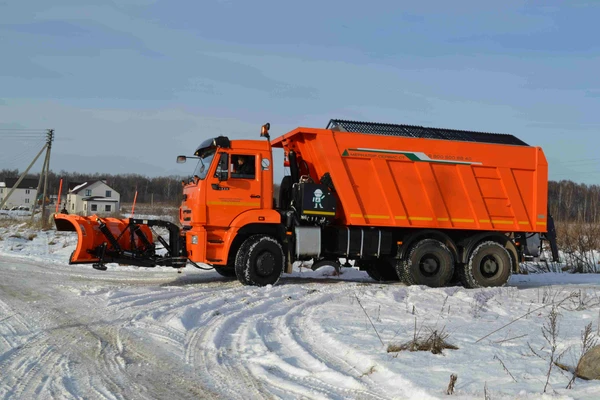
0, 260, 216, 399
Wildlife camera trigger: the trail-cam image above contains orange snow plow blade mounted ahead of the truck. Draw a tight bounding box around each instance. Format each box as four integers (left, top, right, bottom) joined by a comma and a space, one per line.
54, 214, 153, 264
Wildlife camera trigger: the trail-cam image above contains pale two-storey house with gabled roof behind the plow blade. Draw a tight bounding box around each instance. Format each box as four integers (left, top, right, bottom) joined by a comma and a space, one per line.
65, 181, 121, 215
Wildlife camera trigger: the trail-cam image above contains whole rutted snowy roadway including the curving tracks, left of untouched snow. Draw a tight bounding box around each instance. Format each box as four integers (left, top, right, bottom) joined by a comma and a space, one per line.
0, 259, 414, 399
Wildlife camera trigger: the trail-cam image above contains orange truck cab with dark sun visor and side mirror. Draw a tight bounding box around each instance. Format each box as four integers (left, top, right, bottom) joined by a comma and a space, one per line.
178, 136, 281, 276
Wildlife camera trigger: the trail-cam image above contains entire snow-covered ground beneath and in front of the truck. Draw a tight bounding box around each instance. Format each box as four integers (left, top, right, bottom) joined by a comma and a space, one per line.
0, 220, 600, 399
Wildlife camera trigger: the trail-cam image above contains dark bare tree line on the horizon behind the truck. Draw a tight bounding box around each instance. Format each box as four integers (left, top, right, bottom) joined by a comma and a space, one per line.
0, 169, 600, 223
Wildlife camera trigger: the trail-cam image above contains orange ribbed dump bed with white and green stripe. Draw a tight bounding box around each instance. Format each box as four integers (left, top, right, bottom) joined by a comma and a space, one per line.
273, 128, 548, 232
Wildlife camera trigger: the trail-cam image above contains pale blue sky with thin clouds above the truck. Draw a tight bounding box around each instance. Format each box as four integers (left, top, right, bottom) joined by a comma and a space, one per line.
0, 0, 600, 184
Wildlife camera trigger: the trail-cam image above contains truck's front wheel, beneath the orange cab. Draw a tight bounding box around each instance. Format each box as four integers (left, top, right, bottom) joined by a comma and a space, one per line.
235, 235, 285, 286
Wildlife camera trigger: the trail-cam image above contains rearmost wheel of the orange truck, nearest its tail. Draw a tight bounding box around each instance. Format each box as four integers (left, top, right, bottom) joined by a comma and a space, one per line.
460, 241, 512, 288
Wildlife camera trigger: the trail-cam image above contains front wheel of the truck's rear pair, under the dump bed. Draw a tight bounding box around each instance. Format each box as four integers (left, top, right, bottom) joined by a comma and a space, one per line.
396, 239, 454, 287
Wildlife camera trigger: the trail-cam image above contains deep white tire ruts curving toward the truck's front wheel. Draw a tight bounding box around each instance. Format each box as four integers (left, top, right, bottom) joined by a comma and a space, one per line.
169, 288, 390, 399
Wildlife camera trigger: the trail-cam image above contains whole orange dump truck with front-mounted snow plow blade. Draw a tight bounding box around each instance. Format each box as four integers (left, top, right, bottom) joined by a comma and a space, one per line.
55, 120, 558, 287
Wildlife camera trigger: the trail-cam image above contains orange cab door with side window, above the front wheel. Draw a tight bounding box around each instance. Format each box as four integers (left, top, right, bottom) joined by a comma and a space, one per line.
206, 151, 263, 227
